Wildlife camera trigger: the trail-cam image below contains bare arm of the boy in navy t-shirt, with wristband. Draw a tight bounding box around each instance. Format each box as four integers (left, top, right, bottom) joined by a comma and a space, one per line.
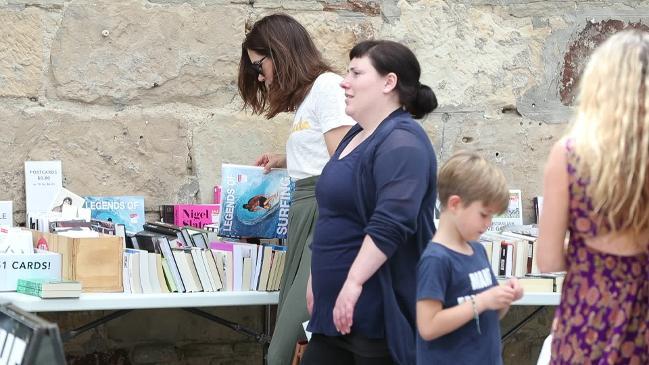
417, 285, 514, 341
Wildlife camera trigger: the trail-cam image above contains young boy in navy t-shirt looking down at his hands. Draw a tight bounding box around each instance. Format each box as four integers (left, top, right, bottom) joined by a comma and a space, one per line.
417, 152, 523, 364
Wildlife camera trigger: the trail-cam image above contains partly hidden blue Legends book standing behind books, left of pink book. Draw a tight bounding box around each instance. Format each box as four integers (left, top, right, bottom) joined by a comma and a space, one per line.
85, 196, 145, 234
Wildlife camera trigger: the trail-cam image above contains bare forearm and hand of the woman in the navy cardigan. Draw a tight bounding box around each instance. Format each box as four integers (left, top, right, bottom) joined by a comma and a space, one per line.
333, 235, 388, 335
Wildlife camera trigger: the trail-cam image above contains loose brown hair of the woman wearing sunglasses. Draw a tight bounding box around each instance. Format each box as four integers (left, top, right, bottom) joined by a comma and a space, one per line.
238, 14, 332, 119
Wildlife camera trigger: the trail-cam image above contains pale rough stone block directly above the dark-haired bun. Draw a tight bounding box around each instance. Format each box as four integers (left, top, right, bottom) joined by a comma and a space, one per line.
379, 2, 550, 113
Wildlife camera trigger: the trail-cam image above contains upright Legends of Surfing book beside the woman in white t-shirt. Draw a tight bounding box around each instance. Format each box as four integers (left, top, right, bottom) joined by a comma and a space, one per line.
219, 164, 294, 239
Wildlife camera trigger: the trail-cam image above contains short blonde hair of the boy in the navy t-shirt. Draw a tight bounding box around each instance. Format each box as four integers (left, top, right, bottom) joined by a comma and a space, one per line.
437, 151, 509, 213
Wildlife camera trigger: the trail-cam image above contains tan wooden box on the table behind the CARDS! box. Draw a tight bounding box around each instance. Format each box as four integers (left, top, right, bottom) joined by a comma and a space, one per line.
32, 231, 124, 292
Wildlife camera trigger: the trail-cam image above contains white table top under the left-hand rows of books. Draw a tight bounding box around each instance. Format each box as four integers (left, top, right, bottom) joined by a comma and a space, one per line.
0, 291, 279, 312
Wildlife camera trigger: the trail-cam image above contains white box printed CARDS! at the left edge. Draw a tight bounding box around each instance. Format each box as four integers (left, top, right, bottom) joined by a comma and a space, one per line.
0, 250, 61, 291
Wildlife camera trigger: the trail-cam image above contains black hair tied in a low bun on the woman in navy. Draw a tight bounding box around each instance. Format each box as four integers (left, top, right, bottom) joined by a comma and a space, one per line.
349, 40, 437, 119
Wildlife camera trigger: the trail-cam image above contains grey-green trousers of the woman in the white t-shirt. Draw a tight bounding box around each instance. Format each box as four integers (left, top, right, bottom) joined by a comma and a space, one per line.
266, 176, 318, 365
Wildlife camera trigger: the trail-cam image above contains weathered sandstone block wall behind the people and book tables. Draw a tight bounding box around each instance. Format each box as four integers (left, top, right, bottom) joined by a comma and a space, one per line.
0, 0, 649, 364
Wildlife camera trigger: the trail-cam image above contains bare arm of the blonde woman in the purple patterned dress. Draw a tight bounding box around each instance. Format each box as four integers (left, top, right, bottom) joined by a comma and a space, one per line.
536, 139, 570, 272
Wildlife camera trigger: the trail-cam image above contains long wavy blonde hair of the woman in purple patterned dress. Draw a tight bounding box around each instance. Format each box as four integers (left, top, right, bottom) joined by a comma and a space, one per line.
570, 31, 649, 237
